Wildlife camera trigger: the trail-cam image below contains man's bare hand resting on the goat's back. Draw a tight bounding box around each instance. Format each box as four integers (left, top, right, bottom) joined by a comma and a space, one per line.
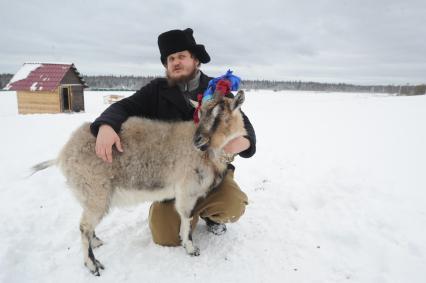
95, 124, 123, 163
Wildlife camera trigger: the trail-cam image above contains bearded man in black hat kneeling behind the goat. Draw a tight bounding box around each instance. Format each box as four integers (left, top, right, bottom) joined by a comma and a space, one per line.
91, 28, 256, 246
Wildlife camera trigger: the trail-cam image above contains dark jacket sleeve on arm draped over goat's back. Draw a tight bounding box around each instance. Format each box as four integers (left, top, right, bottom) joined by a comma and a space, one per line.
90, 82, 157, 136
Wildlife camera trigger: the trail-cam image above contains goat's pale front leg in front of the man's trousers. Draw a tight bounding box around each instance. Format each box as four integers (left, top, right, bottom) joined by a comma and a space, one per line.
175, 194, 200, 256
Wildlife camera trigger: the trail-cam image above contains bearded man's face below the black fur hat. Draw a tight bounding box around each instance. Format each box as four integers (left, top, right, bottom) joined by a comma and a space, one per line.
166, 50, 199, 82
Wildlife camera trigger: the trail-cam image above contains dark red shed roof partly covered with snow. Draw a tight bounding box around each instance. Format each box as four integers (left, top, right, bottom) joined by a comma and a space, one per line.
6, 63, 87, 91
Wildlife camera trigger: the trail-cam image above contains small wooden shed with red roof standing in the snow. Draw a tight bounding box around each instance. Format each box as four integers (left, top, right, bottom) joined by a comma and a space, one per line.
5, 63, 87, 114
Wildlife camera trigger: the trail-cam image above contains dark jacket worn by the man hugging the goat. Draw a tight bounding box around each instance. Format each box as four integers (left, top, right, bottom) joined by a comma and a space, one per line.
90, 73, 256, 158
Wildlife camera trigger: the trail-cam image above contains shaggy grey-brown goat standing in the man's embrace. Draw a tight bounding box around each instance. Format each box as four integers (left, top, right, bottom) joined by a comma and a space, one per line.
33, 90, 247, 276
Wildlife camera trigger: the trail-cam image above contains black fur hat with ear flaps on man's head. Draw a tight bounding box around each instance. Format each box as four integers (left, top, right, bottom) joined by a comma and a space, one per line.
158, 28, 210, 65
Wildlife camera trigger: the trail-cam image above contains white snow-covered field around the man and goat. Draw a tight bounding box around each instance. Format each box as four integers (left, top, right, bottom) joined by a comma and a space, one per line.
0, 91, 426, 283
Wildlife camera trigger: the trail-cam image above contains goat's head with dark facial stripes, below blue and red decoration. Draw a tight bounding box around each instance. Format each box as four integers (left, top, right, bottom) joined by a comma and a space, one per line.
193, 90, 247, 151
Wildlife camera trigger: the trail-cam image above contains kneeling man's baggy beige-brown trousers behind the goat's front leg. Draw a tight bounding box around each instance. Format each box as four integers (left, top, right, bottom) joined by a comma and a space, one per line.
149, 169, 248, 246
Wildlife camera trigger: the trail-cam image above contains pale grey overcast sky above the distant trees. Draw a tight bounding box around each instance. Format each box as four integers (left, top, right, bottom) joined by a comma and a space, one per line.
0, 0, 426, 84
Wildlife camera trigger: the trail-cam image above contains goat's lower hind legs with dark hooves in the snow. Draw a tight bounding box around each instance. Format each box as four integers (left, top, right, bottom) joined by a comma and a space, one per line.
80, 208, 106, 276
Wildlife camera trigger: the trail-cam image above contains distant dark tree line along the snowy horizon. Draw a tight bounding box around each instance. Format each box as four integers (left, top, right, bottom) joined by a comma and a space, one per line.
0, 74, 426, 95
